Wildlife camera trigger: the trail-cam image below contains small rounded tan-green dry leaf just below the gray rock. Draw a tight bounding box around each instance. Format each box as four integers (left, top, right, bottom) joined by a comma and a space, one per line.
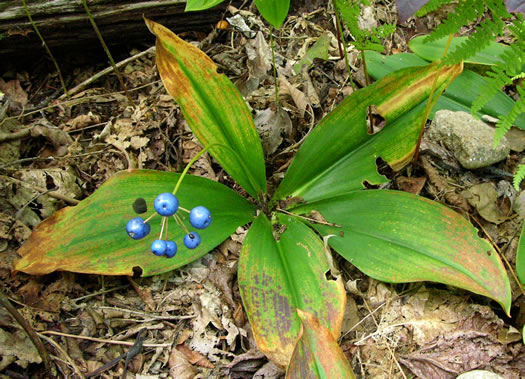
461, 183, 507, 224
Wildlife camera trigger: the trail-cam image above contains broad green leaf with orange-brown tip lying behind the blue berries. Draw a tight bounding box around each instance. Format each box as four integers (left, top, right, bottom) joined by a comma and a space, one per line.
15, 170, 255, 276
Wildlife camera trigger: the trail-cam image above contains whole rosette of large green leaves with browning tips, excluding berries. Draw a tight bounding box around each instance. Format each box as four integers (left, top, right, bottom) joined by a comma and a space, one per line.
16, 20, 511, 377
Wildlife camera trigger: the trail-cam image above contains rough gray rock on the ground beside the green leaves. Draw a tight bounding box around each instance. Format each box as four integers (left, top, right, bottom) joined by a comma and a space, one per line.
427, 110, 510, 169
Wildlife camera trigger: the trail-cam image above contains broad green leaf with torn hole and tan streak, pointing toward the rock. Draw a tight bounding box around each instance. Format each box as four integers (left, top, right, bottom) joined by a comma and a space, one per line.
274, 65, 462, 205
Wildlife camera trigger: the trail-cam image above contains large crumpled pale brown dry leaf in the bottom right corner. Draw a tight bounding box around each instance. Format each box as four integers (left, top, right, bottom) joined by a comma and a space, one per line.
356, 287, 525, 378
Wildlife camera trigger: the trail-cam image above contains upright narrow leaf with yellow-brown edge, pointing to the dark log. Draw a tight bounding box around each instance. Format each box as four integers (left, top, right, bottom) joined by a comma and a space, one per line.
145, 19, 266, 198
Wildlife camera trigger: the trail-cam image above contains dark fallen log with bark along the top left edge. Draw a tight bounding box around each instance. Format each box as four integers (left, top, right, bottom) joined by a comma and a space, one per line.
0, 0, 231, 60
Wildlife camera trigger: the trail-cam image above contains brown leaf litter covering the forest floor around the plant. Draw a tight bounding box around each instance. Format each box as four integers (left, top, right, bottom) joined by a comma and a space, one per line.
0, 1, 525, 379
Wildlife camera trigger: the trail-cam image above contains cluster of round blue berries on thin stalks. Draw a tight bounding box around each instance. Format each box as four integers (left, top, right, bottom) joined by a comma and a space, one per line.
126, 192, 211, 258
